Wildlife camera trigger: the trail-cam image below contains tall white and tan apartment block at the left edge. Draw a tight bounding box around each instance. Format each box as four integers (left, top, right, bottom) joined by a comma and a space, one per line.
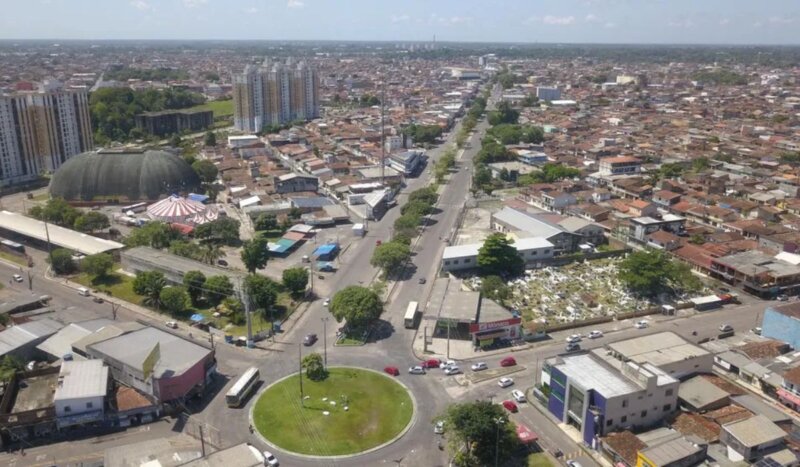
0, 81, 94, 186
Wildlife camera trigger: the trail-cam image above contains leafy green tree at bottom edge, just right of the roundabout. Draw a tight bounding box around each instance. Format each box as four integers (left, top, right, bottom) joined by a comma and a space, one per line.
439, 401, 519, 467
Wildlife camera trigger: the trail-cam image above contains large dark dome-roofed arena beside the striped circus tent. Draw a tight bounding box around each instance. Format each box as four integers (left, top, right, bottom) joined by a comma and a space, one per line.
50, 149, 201, 201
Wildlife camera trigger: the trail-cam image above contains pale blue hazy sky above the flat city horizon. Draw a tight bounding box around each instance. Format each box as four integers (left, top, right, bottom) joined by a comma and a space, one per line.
0, 0, 800, 44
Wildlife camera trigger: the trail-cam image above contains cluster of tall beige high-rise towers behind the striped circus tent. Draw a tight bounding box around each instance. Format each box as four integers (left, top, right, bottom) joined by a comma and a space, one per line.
233, 59, 319, 132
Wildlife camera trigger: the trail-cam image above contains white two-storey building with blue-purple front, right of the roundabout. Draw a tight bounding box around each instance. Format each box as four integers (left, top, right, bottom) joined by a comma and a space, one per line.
542, 353, 680, 448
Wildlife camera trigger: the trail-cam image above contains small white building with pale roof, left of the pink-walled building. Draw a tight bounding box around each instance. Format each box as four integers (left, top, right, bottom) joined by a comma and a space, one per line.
53, 360, 108, 428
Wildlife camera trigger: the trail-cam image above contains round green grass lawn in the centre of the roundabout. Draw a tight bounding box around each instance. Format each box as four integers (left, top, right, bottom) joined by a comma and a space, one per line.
253, 368, 413, 456
